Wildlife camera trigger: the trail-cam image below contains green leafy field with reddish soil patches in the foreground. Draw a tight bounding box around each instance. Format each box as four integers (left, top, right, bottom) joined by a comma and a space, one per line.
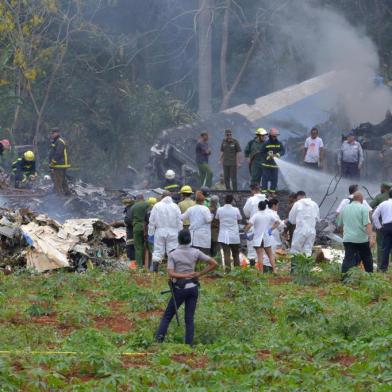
0, 264, 392, 391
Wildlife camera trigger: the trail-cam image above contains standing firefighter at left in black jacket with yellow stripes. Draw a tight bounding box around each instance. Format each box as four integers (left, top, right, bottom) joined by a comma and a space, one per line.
49, 128, 71, 195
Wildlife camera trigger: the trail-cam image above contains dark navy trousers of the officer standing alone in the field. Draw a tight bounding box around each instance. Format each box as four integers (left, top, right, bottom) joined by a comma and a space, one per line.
156, 286, 199, 345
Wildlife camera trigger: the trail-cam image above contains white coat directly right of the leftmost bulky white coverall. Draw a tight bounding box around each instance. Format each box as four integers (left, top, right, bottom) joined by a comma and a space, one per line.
181, 204, 212, 249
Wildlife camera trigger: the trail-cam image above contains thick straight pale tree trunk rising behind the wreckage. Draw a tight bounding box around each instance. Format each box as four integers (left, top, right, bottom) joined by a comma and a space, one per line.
198, 0, 213, 118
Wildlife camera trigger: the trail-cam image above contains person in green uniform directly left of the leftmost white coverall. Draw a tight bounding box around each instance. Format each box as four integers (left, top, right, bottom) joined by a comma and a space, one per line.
130, 194, 150, 268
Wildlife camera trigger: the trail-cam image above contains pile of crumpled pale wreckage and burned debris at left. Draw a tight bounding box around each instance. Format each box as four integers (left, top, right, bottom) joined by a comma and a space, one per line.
0, 208, 128, 272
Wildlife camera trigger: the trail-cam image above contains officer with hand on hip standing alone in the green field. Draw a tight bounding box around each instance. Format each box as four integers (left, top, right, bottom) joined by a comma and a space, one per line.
156, 229, 218, 346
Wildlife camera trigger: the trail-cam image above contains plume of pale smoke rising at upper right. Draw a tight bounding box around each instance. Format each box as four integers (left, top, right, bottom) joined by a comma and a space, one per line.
279, 0, 392, 126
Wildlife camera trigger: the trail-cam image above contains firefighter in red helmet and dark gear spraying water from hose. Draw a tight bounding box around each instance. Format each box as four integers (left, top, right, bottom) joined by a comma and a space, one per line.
261, 128, 285, 193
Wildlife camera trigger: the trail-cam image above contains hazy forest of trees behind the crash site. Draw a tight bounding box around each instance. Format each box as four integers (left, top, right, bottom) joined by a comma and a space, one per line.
0, 0, 392, 185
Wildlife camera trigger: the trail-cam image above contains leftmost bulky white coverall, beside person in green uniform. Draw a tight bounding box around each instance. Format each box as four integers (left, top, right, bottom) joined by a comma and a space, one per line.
148, 196, 182, 263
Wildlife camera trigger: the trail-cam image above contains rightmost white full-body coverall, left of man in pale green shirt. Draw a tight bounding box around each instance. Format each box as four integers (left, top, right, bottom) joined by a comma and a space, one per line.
289, 198, 320, 256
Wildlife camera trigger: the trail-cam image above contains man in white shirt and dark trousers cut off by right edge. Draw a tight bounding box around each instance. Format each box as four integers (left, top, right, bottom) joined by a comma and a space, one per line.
372, 190, 392, 272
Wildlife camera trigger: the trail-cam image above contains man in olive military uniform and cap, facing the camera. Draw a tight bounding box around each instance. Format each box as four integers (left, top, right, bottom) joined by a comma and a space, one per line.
219, 129, 241, 191
